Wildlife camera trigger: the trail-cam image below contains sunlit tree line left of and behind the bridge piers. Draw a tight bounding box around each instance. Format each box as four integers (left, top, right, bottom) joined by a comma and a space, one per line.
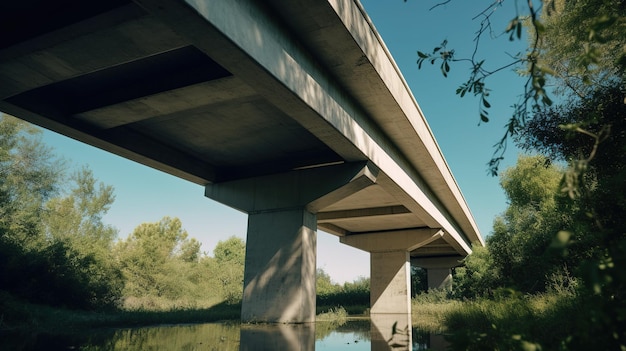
0, 115, 369, 310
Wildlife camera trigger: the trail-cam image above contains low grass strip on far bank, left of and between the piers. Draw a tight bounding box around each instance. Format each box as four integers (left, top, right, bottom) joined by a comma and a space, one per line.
0, 292, 369, 335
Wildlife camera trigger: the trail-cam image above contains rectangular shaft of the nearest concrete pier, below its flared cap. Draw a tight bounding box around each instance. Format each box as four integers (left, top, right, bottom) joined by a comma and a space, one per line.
241, 208, 317, 323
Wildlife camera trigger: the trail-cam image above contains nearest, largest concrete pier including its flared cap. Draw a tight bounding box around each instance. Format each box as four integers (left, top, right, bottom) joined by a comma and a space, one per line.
205, 162, 378, 323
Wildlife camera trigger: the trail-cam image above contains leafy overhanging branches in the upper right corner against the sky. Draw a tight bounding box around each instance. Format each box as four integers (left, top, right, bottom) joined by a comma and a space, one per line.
412, 0, 626, 175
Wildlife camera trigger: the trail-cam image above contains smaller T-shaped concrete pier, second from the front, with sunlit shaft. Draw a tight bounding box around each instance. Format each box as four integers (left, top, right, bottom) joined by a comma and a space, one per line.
340, 229, 443, 315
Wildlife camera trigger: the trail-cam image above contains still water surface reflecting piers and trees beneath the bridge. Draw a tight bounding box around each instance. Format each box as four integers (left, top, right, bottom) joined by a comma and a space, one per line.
11, 316, 447, 351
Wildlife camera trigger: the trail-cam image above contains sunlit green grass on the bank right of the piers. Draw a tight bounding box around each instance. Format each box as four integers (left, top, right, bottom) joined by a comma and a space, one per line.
412, 293, 578, 350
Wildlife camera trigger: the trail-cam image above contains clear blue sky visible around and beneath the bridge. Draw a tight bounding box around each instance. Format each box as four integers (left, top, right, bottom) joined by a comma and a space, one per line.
36, 0, 524, 283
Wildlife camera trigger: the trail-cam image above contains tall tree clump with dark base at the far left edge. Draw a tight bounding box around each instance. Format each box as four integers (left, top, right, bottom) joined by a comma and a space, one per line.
0, 115, 120, 308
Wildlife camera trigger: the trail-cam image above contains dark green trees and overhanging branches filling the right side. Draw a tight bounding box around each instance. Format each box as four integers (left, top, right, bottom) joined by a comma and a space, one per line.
417, 0, 626, 350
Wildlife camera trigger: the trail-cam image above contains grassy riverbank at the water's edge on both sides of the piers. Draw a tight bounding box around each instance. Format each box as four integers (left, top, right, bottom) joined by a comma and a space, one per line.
0, 293, 575, 346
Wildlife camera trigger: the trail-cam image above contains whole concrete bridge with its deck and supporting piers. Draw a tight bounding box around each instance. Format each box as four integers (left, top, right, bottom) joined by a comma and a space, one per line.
0, 0, 482, 322
